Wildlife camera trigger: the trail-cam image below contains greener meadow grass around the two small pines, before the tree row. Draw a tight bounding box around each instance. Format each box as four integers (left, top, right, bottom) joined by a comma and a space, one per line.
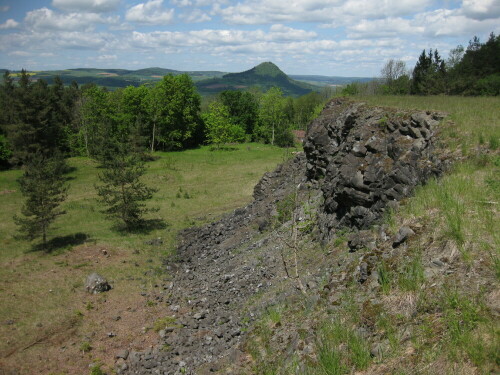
0, 144, 283, 261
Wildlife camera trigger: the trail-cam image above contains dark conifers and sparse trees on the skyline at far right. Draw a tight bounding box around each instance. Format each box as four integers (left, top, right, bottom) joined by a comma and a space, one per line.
342, 33, 500, 96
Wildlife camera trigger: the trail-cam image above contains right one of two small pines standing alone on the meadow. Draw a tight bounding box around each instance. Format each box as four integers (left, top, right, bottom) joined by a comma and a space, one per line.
95, 146, 157, 231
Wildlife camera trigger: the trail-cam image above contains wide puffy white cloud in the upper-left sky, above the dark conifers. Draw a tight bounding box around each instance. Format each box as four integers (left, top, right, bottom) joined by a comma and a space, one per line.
24, 8, 117, 31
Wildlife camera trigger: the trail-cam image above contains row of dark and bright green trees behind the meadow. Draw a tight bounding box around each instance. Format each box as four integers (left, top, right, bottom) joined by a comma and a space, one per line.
0, 70, 327, 168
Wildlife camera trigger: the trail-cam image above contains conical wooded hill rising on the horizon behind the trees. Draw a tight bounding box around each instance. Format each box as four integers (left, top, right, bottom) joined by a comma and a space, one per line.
196, 62, 314, 96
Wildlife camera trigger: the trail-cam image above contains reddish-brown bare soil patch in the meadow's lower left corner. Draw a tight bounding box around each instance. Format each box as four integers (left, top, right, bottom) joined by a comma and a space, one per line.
0, 244, 169, 374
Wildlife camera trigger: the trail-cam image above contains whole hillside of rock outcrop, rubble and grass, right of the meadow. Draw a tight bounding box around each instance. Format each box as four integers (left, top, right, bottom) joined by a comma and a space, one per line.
115, 99, 500, 375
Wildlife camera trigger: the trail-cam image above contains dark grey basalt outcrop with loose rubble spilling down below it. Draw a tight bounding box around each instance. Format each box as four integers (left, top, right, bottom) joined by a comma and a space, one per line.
120, 99, 444, 374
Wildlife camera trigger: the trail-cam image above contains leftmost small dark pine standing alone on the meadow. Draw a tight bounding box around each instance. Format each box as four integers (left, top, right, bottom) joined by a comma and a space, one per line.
14, 153, 68, 249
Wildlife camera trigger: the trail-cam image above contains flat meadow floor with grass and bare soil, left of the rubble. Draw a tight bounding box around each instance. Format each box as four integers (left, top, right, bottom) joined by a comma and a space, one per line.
0, 144, 290, 373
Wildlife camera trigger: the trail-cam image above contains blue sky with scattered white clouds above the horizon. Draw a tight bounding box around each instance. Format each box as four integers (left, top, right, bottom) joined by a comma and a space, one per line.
0, 0, 500, 77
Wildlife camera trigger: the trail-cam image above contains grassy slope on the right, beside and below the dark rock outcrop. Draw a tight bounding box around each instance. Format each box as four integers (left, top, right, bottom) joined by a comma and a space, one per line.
244, 96, 500, 375
